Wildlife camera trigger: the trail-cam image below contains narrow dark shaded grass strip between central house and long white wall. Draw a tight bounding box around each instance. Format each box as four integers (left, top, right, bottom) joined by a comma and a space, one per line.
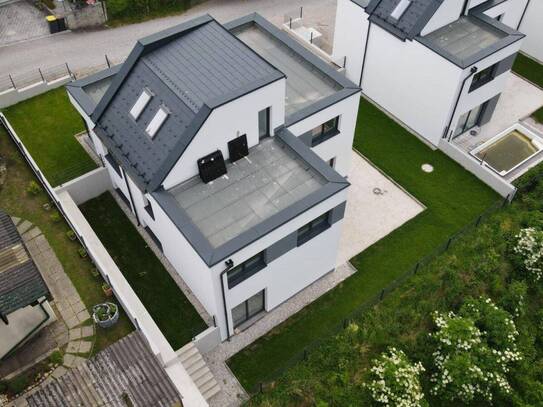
80, 192, 206, 349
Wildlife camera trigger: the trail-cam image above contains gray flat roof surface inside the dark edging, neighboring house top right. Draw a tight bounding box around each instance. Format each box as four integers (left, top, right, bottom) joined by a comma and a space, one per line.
426, 17, 507, 59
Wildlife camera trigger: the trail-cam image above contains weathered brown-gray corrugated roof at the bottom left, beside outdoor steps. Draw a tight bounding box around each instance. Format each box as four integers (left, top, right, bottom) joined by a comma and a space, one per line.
26, 331, 182, 407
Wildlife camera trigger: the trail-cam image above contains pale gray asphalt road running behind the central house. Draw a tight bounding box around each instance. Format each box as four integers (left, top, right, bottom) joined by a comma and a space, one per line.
0, 0, 336, 76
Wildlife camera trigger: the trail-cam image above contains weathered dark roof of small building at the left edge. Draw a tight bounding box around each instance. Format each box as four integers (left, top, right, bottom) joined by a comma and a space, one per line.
0, 210, 51, 316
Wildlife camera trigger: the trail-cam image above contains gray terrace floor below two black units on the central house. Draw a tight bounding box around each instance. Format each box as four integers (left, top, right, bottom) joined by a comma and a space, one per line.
170, 137, 326, 248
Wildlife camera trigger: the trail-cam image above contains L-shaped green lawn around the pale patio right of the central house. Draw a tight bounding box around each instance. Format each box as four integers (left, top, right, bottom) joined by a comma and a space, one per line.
229, 100, 498, 391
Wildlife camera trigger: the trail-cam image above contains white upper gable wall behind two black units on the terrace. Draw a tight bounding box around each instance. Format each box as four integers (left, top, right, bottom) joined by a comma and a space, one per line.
163, 79, 286, 189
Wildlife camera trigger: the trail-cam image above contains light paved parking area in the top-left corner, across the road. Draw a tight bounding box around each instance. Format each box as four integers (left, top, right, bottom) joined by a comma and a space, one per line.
0, 0, 49, 47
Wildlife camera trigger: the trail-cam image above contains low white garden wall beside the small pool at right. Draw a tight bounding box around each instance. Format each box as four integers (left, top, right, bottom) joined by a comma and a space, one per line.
439, 139, 517, 200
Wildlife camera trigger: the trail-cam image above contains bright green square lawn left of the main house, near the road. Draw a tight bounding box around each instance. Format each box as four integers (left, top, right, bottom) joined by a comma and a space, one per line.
4, 87, 96, 186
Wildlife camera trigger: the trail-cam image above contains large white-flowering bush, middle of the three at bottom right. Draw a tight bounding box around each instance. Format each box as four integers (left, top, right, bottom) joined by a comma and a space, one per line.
430, 298, 521, 403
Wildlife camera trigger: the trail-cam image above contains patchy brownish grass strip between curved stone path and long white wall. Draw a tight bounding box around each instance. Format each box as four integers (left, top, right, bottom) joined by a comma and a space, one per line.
0, 126, 134, 352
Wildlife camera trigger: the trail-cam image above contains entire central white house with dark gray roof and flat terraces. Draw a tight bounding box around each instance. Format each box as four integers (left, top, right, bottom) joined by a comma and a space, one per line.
67, 14, 360, 340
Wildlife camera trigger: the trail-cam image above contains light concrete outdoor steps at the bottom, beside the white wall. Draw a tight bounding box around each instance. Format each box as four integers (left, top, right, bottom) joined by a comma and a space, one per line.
176, 342, 221, 400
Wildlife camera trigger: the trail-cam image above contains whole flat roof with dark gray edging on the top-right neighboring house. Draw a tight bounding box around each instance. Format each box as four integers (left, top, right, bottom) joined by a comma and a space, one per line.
419, 14, 524, 67
